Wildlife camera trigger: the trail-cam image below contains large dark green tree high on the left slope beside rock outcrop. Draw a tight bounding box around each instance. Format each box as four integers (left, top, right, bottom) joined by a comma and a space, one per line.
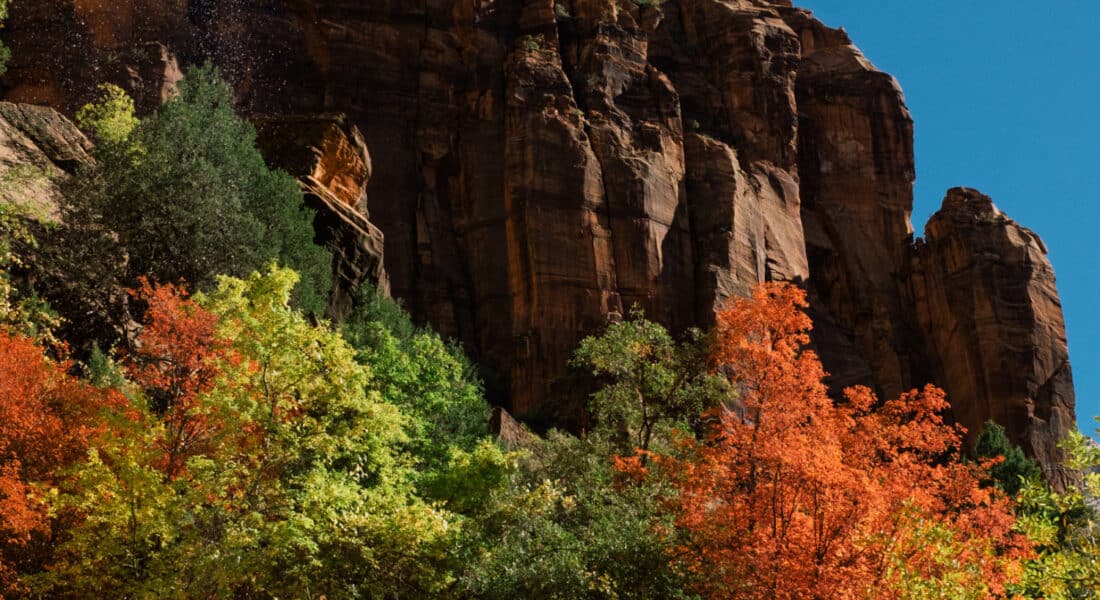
55, 65, 331, 314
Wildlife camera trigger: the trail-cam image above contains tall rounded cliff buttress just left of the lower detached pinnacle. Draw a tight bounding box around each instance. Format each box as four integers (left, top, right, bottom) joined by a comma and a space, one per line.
788, 12, 926, 396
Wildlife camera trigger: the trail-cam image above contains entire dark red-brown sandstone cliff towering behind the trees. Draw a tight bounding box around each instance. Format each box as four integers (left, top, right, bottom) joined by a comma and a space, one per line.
4, 0, 1073, 459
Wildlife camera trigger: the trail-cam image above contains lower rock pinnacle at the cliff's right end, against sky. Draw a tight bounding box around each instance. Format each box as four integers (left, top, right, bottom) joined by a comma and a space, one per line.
908, 188, 1076, 481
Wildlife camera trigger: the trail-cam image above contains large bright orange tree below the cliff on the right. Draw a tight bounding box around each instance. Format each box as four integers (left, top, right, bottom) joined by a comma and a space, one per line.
634, 284, 1027, 599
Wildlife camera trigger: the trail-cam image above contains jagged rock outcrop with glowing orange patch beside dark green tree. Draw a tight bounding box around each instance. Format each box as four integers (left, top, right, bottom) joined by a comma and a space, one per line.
255, 116, 389, 320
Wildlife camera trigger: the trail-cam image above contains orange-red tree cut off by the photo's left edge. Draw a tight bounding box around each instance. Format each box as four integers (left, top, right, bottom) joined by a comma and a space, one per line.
0, 328, 125, 597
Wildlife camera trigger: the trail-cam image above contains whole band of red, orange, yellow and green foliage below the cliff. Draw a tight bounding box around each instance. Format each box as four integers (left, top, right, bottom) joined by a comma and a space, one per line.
0, 247, 1096, 599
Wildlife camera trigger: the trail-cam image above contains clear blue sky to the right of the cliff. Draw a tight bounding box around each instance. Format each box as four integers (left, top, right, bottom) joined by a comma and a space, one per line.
794, 0, 1100, 434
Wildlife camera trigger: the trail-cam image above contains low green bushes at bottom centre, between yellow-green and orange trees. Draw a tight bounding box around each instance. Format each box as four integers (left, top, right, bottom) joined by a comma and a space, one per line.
455, 432, 690, 599
